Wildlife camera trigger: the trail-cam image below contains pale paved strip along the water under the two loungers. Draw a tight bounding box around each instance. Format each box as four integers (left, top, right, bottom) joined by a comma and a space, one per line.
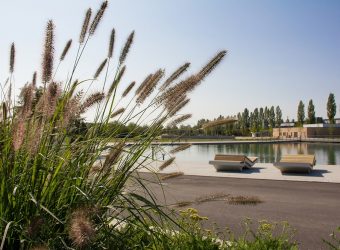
141, 161, 340, 183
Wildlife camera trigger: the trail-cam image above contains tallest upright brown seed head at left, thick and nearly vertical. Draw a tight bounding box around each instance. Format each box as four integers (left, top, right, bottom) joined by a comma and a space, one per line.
41, 20, 54, 84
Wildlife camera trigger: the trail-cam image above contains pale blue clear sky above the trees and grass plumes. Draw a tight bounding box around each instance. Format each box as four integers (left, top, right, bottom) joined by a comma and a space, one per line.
0, 0, 340, 122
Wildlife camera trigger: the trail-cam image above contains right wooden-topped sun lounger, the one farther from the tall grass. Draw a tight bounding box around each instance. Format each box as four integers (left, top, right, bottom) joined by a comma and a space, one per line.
274, 154, 316, 173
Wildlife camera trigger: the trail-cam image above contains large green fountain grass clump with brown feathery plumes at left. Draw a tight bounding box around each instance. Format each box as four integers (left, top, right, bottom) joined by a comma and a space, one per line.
0, 1, 226, 250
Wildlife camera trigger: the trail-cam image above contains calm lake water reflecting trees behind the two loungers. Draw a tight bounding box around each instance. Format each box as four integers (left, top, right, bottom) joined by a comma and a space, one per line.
156, 143, 340, 165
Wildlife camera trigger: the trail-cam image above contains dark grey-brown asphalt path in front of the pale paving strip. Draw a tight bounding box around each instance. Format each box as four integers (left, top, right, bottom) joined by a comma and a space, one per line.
142, 173, 340, 249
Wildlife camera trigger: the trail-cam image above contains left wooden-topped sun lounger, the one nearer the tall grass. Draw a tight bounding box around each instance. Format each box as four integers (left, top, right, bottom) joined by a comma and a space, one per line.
209, 154, 257, 171
